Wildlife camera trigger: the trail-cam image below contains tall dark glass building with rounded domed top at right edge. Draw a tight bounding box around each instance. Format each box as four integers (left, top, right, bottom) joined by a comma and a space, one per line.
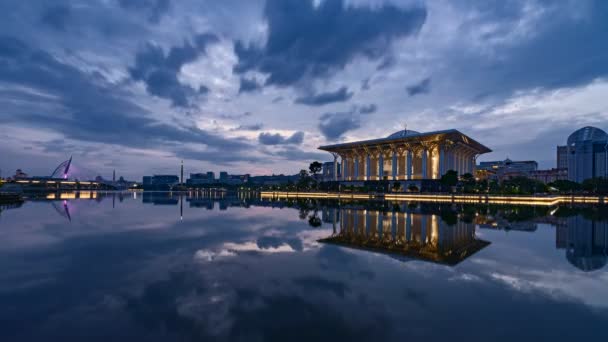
566, 126, 608, 183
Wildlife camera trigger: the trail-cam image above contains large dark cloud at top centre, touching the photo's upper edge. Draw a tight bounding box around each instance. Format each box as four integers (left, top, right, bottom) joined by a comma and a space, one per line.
235, 0, 427, 86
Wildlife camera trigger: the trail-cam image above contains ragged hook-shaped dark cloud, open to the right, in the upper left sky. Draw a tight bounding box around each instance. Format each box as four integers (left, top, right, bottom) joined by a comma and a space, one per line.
129, 34, 218, 107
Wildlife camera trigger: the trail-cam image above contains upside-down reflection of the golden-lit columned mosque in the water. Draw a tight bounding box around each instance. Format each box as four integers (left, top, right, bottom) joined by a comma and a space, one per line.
320, 205, 490, 265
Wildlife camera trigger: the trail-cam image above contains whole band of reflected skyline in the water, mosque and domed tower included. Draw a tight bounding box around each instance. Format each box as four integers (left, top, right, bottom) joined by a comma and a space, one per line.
5, 192, 608, 271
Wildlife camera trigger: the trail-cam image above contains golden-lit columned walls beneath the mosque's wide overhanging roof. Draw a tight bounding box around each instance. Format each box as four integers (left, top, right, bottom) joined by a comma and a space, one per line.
332, 144, 478, 181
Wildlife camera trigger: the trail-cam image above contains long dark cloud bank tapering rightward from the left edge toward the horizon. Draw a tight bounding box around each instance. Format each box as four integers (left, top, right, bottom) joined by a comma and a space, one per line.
0, 37, 249, 161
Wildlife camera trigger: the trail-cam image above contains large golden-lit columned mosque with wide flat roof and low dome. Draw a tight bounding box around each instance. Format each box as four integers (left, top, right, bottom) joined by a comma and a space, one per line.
319, 129, 492, 181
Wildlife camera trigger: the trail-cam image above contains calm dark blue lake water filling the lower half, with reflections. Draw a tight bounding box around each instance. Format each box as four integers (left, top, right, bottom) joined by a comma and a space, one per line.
0, 193, 608, 341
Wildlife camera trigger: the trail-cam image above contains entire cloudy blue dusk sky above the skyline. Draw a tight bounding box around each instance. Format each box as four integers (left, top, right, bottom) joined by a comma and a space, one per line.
0, 0, 608, 180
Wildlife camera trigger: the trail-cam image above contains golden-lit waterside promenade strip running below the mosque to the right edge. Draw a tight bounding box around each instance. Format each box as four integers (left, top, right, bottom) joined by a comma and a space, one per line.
261, 191, 607, 206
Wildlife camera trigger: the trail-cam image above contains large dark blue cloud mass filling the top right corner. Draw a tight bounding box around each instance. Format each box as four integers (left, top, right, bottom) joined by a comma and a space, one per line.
449, 1, 608, 96
